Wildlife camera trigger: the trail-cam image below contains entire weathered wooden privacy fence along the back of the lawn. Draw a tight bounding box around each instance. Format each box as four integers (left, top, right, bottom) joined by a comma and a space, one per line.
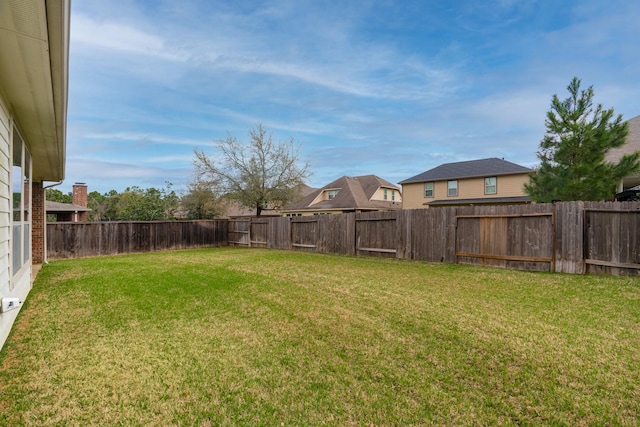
47, 202, 640, 275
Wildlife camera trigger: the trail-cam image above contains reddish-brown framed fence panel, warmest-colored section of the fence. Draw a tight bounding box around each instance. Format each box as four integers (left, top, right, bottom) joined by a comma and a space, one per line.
456, 213, 555, 271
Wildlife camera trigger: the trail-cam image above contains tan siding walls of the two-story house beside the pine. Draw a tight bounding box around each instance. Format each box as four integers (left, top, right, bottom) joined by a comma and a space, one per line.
402, 174, 529, 209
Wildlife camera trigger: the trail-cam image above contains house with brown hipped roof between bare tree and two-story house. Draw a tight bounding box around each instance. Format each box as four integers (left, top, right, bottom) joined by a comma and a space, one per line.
282, 175, 402, 216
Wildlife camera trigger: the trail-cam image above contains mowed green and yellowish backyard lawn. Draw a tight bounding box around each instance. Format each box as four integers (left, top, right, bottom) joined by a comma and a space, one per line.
0, 248, 640, 426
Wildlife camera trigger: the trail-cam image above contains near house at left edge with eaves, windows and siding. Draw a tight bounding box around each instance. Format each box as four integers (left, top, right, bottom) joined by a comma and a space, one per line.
0, 0, 70, 347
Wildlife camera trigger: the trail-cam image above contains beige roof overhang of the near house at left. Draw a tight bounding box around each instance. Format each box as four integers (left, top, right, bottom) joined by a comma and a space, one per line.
0, 0, 70, 182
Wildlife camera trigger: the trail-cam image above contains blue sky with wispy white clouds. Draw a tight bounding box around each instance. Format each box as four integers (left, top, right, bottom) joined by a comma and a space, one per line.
63, 0, 640, 193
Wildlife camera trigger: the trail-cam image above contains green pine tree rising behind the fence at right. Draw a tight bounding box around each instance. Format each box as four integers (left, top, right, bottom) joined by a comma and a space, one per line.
525, 77, 640, 202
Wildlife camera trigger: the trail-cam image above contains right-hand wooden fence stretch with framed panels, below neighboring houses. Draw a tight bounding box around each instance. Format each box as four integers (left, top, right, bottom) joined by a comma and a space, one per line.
229, 202, 640, 274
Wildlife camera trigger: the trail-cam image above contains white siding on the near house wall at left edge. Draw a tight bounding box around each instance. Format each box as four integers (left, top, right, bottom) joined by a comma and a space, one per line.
0, 97, 31, 348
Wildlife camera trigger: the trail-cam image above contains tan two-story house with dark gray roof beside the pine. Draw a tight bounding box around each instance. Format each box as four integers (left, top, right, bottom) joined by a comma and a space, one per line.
400, 157, 534, 209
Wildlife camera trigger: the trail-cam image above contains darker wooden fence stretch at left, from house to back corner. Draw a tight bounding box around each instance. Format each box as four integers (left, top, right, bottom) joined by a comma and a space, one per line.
47, 220, 229, 259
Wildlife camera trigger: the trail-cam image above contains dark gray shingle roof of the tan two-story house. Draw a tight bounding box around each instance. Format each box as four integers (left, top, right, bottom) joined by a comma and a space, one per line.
400, 157, 533, 184
